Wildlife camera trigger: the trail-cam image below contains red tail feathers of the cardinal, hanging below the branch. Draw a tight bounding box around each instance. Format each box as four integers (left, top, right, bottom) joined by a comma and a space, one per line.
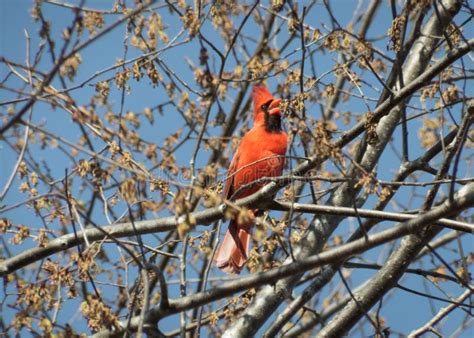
214, 221, 250, 273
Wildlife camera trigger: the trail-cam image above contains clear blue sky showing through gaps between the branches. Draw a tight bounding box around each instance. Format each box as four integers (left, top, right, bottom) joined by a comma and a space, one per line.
0, 0, 472, 334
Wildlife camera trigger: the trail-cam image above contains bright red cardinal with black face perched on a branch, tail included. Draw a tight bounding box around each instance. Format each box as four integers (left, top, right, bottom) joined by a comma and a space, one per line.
214, 86, 288, 273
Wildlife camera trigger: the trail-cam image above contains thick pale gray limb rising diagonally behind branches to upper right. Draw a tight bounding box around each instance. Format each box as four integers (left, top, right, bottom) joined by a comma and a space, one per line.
223, 0, 460, 338
